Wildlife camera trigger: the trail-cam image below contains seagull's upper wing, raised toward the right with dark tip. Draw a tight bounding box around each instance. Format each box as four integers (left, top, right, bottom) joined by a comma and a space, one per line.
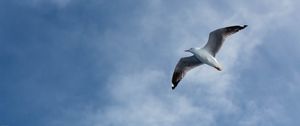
204, 25, 247, 56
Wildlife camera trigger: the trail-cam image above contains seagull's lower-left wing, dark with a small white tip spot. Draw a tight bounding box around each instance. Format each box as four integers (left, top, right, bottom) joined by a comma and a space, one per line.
172, 56, 202, 89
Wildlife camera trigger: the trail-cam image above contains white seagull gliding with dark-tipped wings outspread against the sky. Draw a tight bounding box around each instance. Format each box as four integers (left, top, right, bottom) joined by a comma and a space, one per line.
172, 25, 247, 90
